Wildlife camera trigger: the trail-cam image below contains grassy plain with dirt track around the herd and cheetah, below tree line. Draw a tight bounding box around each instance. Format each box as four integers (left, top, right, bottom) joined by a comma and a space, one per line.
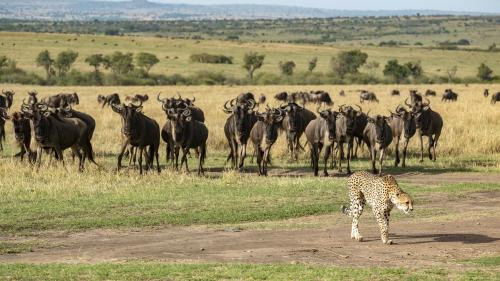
0, 82, 500, 280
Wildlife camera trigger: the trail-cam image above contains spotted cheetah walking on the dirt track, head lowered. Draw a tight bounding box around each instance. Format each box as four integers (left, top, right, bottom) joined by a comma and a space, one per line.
341, 172, 413, 245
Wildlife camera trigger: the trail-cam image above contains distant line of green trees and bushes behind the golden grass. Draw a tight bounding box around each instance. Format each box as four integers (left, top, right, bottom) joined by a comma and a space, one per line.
0, 50, 499, 85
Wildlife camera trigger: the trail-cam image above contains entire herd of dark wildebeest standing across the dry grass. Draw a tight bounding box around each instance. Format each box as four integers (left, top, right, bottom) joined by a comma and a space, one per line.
0, 89, 500, 176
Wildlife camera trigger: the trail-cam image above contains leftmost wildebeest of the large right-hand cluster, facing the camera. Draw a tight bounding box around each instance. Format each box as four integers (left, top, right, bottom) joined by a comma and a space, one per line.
224, 99, 257, 169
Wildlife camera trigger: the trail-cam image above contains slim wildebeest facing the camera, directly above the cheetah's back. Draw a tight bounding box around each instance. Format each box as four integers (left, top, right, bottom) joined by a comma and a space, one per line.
364, 115, 392, 174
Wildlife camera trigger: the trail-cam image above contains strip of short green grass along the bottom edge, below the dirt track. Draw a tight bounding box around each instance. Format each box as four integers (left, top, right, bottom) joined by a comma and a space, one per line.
0, 263, 499, 280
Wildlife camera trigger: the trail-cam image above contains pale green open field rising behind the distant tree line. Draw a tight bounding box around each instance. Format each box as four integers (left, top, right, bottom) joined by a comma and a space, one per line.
0, 32, 500, 78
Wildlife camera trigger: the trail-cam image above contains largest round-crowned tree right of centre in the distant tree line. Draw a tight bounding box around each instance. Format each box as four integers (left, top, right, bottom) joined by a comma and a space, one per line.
330, 50, 368, 78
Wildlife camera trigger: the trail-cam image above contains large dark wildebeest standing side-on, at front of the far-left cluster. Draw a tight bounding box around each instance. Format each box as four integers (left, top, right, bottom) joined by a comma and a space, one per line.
21, 103, 93, 171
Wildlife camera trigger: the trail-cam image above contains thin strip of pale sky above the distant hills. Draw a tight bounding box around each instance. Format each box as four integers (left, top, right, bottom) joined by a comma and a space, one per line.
150, 0, 500, 13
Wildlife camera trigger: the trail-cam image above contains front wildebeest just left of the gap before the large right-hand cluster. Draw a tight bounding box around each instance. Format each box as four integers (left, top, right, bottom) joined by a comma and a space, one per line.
168, 106, 208, 175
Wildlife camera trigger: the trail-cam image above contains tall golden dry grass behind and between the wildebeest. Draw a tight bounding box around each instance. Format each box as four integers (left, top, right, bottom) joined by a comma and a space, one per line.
0, 84, 500, 161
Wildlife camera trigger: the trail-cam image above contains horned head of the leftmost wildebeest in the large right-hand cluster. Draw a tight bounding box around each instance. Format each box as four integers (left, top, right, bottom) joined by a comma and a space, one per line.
224, 99, 255, 138
